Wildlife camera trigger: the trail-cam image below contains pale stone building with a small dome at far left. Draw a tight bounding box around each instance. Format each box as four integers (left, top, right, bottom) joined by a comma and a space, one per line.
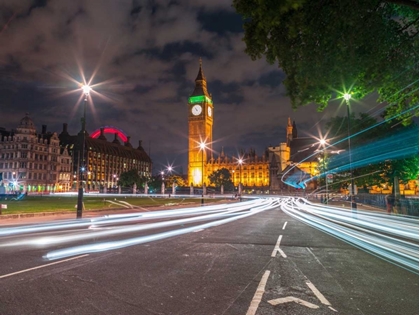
0, 114, 72, 193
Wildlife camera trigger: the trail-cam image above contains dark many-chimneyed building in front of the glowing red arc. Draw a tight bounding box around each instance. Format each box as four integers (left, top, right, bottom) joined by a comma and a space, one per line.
58, 124, 152, 192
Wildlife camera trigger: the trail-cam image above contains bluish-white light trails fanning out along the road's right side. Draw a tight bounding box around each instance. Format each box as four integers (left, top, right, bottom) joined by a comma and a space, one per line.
281, 197, 419, 274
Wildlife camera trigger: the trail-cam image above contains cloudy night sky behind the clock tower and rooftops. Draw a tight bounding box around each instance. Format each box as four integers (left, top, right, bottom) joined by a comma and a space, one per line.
0, 0, 374, 173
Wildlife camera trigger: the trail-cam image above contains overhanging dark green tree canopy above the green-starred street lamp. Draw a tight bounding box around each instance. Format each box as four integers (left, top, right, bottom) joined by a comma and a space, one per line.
233, 0, 419, 124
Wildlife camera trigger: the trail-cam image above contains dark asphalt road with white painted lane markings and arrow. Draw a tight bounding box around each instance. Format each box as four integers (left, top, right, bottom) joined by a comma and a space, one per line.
0, 204, 419, 315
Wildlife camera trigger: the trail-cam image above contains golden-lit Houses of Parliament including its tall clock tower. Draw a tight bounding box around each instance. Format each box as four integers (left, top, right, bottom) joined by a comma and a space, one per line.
188, 60, 318, 193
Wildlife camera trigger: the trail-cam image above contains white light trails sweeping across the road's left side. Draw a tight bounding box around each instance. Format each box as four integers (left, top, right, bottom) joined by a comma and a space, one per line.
0, 198, 280, 260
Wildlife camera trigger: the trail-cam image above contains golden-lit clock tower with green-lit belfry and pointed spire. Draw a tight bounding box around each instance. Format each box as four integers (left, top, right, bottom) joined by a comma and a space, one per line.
188, 58, 213, 186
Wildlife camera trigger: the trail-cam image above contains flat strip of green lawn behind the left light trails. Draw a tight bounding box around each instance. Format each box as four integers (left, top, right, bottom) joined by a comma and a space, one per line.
0, 196, 208, 214
